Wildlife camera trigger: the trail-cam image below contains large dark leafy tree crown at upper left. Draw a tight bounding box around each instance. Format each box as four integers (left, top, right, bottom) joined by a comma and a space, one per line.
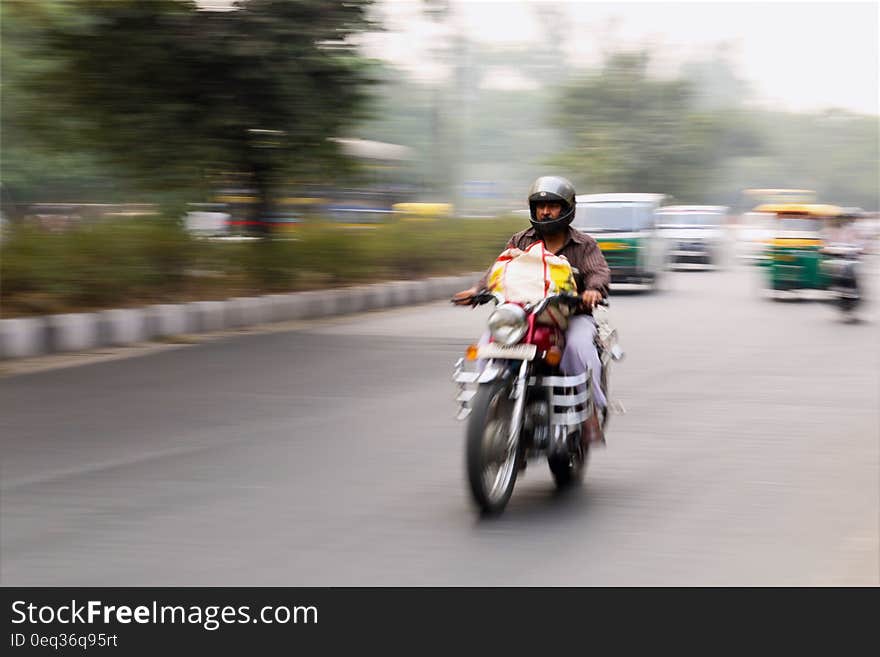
10, 0, 371, 231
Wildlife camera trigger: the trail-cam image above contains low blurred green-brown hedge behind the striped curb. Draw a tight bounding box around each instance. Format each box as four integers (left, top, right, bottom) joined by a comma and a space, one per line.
0, 217, 523, 317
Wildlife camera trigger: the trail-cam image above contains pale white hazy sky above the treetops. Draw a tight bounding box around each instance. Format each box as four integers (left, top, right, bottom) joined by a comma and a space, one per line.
368, 0, 880, 114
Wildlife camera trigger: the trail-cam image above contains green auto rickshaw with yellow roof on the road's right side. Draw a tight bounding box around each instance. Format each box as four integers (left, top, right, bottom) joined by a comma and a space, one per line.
754, 203, 842, 291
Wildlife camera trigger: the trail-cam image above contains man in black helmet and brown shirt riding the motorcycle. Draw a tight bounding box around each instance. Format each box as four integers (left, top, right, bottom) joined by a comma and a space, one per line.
453, 176, 611, 444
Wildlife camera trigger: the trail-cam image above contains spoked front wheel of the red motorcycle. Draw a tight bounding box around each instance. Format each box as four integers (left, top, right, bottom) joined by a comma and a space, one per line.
466, 381, 522, 514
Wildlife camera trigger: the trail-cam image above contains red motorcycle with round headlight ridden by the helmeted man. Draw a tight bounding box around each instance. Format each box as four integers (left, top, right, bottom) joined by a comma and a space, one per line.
453, 290, 623, 514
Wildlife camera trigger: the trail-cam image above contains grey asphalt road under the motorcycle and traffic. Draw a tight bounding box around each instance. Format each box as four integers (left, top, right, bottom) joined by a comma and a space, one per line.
0, 262, 880, 586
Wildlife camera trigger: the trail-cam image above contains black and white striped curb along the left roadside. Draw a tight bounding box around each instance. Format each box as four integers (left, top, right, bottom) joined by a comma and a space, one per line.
0, 272, 482, 359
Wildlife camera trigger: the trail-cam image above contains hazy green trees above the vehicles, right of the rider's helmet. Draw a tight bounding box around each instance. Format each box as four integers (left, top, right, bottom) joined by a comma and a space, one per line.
549, 48, 880, 210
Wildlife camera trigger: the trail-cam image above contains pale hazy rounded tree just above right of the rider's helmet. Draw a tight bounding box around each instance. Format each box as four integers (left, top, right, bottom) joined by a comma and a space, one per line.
553, 52, 756, 202
